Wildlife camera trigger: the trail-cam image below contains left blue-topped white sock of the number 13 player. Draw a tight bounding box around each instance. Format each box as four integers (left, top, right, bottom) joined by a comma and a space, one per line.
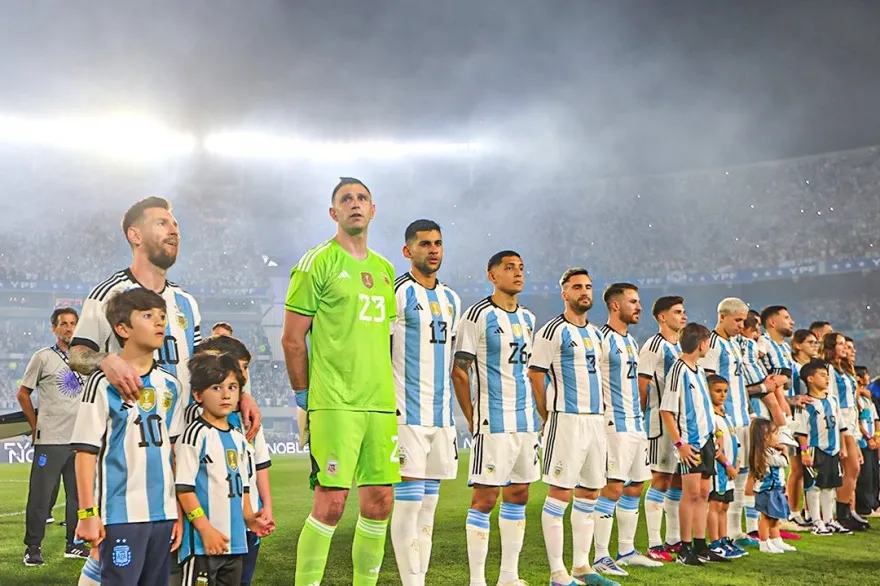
391, 480, 425, 586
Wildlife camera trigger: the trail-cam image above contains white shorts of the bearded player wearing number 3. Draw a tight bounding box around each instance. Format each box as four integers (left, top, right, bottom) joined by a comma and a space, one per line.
541, 413, 607, 490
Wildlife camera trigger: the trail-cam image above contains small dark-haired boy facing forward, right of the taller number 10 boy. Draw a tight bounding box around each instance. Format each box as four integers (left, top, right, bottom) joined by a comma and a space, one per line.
175, 353, 272, 586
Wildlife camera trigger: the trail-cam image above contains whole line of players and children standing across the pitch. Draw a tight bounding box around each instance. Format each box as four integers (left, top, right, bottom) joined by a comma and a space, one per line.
15, 178, 880, 586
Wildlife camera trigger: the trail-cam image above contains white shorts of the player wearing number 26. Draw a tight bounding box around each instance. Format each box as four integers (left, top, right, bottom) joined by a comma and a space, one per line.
468, 431, 541, 486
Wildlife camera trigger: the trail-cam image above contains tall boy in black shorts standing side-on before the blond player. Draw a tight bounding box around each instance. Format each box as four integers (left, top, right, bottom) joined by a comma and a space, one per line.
660, 324, 727, 566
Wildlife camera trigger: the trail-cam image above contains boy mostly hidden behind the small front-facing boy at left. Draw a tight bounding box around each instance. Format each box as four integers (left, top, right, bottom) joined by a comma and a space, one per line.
185, 334, 275, 586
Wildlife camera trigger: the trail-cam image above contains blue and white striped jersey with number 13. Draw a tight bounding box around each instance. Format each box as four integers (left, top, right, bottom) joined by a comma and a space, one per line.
391, 273, 461, 427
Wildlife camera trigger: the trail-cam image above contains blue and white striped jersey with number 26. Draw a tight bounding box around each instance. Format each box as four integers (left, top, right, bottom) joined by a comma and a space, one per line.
455, 297, 540, 434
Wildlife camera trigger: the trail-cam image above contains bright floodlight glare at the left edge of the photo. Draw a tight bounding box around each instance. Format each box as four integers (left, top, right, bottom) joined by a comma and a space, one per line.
0, 114, 196, 160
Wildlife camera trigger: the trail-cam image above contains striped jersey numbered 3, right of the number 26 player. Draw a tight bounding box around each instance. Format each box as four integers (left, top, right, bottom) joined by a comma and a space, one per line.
529, 315, 605, 415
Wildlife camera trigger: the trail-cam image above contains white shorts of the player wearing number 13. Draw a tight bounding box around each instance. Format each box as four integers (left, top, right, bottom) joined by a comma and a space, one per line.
397, 425, 458, 480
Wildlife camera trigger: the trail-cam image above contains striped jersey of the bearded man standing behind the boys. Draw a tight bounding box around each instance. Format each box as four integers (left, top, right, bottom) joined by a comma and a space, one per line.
70, 269, 202, 406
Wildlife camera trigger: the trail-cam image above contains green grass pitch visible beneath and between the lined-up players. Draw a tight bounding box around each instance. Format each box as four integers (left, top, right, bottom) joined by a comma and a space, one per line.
0, 457, 880, 586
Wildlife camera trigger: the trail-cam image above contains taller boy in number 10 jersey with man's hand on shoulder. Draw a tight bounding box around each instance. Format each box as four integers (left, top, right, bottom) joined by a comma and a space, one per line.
71, 287, 183, 586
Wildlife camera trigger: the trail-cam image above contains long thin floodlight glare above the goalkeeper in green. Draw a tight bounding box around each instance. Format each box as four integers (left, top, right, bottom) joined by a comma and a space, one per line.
203, 132, 482, 161
